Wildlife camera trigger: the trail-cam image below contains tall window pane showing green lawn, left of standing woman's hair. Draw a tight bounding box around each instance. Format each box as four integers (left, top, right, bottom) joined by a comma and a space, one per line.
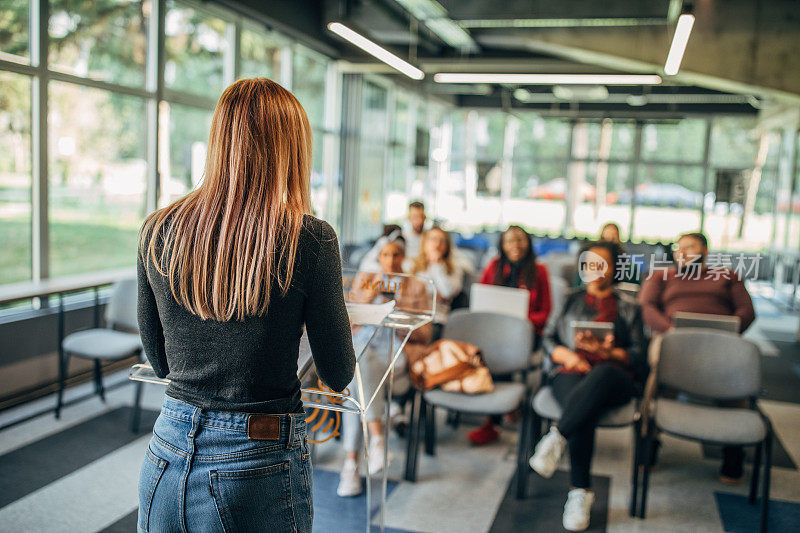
48, 82, 146, 277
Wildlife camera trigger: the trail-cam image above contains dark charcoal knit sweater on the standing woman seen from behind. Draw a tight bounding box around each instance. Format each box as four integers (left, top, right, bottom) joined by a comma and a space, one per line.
138, 215, 355, 413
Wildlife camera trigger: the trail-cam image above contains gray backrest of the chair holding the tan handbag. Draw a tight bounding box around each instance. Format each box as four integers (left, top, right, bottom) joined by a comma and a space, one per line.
442, 309, 533, 374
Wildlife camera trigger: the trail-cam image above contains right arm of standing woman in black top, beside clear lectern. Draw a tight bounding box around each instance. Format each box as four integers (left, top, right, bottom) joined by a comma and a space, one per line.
304, 222, 356, 392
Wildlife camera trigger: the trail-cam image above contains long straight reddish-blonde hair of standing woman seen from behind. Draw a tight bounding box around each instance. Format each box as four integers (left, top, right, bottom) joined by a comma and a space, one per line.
139, 78, 313, 321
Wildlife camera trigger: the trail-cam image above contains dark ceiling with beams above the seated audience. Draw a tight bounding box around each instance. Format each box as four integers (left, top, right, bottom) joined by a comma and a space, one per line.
217, 0, 800, 115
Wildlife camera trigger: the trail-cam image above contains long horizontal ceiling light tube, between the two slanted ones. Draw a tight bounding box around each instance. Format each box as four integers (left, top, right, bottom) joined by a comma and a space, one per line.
433, 72, 661, 85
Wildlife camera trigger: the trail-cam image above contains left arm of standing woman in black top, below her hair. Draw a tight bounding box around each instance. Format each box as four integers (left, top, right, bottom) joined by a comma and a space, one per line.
136, 240, 169, 378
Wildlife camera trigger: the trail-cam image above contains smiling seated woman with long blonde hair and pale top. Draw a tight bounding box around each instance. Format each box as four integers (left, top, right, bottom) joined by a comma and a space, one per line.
411, 226, 464, 334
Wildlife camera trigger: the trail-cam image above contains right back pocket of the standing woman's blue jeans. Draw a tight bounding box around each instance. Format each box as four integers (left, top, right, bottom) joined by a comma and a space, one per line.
209, 461, 297, 533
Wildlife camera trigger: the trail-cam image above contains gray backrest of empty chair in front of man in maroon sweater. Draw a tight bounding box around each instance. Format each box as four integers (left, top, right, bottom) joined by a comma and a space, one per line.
658, 328, 761, 400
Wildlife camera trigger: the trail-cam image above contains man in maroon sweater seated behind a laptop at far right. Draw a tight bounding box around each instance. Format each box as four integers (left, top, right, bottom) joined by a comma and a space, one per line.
639, 233, 756, 484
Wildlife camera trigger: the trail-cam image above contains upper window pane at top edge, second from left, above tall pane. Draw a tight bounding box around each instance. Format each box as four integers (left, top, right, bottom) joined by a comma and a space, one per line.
48, 0, 147, 86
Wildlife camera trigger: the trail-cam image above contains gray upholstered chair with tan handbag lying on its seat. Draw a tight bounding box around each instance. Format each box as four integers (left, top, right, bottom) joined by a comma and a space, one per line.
405, 309, 534, 498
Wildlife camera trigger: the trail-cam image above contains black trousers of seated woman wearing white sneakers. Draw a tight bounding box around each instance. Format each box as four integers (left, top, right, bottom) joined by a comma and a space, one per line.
552, 363, 635, 489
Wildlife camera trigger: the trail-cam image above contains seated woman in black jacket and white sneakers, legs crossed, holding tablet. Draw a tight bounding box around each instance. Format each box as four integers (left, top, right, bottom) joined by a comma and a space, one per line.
530, 242, 647, 531
